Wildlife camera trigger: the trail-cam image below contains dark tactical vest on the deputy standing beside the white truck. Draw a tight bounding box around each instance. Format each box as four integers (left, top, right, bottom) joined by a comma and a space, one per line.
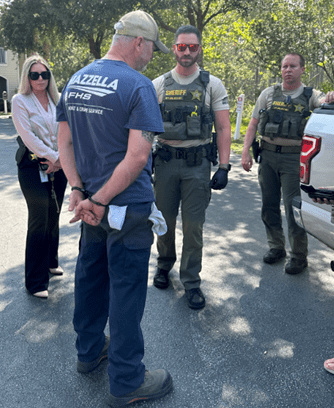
258, 85, 312, 140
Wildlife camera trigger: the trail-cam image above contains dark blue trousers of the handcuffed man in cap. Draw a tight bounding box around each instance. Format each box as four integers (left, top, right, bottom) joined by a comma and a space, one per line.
73, 203, 153, 396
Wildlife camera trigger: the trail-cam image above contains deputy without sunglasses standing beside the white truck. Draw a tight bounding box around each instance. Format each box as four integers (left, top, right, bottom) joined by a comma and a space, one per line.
241, 53, 328, 274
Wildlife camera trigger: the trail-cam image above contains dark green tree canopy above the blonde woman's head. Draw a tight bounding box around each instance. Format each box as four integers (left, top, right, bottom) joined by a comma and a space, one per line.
0, 0, 132, 58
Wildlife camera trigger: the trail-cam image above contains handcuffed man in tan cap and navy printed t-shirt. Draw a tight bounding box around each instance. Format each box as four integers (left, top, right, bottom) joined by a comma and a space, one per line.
57, 11, 172, 406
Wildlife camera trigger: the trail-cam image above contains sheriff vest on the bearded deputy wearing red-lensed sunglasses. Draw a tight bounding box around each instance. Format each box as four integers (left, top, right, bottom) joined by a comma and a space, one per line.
160, 72, 214, 140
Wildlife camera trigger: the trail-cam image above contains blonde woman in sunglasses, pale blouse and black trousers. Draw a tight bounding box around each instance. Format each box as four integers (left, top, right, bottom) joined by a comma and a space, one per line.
12, 55, 67, 298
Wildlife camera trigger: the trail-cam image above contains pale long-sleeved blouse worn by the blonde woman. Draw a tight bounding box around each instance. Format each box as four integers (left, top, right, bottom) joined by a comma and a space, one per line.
12, 93, 59, 163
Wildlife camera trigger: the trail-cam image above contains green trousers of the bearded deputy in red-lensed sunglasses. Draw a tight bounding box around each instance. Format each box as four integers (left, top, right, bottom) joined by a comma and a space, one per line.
154, 157, 211, 290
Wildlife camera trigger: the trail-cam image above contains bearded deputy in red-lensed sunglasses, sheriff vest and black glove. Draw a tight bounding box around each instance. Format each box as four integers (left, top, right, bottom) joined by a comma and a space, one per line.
153, 25, 231, 309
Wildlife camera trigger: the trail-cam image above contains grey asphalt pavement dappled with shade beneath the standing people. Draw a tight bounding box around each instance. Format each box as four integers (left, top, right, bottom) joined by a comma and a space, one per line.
0, 117, 334, 408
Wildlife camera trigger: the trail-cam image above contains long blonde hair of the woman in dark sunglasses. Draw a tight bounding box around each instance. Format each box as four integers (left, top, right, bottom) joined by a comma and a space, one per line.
19, 55, 59, 105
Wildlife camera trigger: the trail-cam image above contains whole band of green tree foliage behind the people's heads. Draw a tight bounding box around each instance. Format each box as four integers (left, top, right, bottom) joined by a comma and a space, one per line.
0, 0, 334, 106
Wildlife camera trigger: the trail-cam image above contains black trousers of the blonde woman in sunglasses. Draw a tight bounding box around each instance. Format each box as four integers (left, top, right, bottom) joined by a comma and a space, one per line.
18, 164, 67, 293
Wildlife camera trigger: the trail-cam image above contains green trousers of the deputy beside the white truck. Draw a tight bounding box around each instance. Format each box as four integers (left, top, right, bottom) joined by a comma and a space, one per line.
259, 150, 307, 259
